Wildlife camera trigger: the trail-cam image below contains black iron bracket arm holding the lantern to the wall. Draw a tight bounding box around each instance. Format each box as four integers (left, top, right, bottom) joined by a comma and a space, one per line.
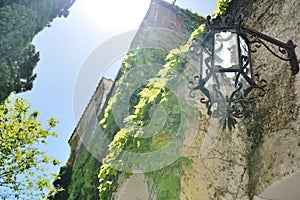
242, 27, 299, 75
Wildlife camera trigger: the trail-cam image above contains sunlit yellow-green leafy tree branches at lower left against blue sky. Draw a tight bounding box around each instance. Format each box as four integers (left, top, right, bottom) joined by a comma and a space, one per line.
0, 98, 59, 199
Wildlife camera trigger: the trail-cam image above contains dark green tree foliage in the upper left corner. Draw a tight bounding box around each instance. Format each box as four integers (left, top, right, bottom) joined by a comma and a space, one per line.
0, 0, 74, 102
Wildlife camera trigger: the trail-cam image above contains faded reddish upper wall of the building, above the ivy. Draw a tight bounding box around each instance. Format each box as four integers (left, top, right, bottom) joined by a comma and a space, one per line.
131, 0, 204, 51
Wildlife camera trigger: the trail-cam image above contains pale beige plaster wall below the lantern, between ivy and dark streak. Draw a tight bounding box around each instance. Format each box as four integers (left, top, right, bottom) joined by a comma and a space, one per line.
181, 101, 249, 200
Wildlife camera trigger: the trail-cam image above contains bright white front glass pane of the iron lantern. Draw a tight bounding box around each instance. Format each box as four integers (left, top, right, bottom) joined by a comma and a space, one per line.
214, 31, 239, 68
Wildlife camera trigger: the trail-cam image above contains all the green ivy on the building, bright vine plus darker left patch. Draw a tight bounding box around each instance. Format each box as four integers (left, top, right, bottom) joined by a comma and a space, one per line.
52, 0, 234, 200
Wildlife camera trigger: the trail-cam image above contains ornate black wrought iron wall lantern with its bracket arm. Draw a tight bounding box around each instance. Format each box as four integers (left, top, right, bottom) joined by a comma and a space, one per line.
189, 15, 299, 130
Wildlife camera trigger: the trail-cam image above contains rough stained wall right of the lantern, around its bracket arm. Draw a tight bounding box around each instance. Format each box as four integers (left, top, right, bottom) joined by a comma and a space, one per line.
228, 0, 300, 197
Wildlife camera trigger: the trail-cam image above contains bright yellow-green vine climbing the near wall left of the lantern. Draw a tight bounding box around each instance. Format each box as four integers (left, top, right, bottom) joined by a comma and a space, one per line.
99, 0, 230, 199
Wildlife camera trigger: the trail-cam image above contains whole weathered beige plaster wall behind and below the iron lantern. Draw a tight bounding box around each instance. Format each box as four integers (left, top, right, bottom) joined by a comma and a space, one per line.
181, 0, 300, 200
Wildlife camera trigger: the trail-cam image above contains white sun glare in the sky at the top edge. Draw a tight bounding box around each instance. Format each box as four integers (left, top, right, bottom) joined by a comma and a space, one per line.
81, 0, 150, 31
